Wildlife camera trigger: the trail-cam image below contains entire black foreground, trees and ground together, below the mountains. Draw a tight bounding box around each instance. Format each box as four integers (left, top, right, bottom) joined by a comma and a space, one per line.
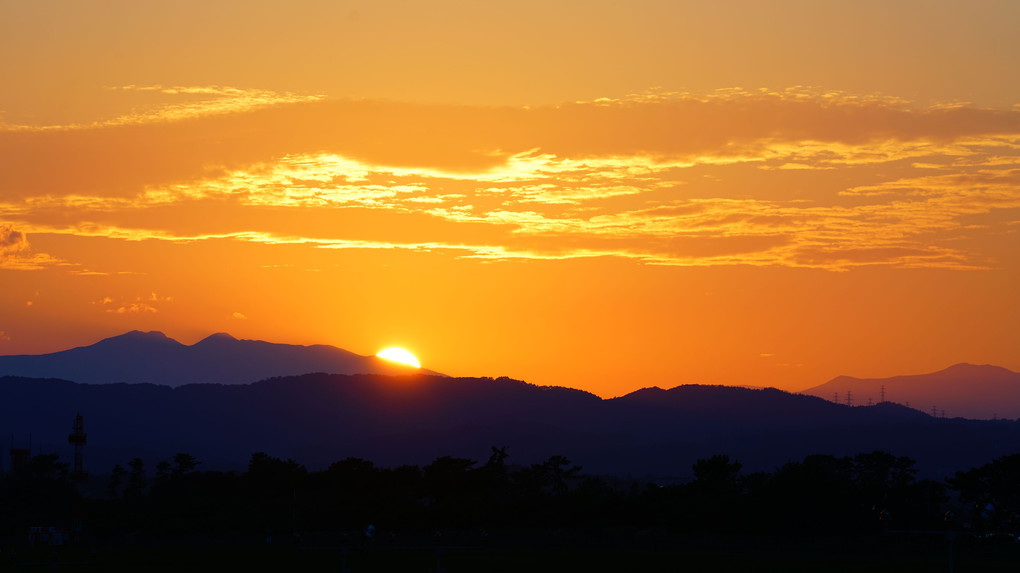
0, 448, 1020, 573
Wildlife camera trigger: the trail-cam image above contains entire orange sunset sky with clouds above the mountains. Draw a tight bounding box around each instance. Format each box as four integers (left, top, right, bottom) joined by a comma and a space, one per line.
0, 0, 1020, 397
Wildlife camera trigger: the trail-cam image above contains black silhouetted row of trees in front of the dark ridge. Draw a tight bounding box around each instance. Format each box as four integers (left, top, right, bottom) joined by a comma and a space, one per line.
0, 447, 1020, 540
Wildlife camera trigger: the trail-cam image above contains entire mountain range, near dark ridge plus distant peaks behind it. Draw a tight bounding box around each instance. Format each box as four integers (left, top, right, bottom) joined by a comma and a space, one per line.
0, 331, 1020, 479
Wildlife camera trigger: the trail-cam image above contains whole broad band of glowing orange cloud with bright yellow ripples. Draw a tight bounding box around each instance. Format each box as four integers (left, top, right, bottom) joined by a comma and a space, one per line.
0, 86, 1020, 269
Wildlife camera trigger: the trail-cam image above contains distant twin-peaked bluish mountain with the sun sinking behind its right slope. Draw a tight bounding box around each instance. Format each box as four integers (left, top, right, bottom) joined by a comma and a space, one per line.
0, 330, 436, 386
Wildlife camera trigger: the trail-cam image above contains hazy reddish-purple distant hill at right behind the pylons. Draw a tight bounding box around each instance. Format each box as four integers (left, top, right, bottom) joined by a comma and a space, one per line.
801, 364, 1020, 419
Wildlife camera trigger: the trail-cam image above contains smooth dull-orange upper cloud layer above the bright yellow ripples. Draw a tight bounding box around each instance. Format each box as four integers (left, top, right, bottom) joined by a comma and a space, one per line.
0, 91, 1020, 197
